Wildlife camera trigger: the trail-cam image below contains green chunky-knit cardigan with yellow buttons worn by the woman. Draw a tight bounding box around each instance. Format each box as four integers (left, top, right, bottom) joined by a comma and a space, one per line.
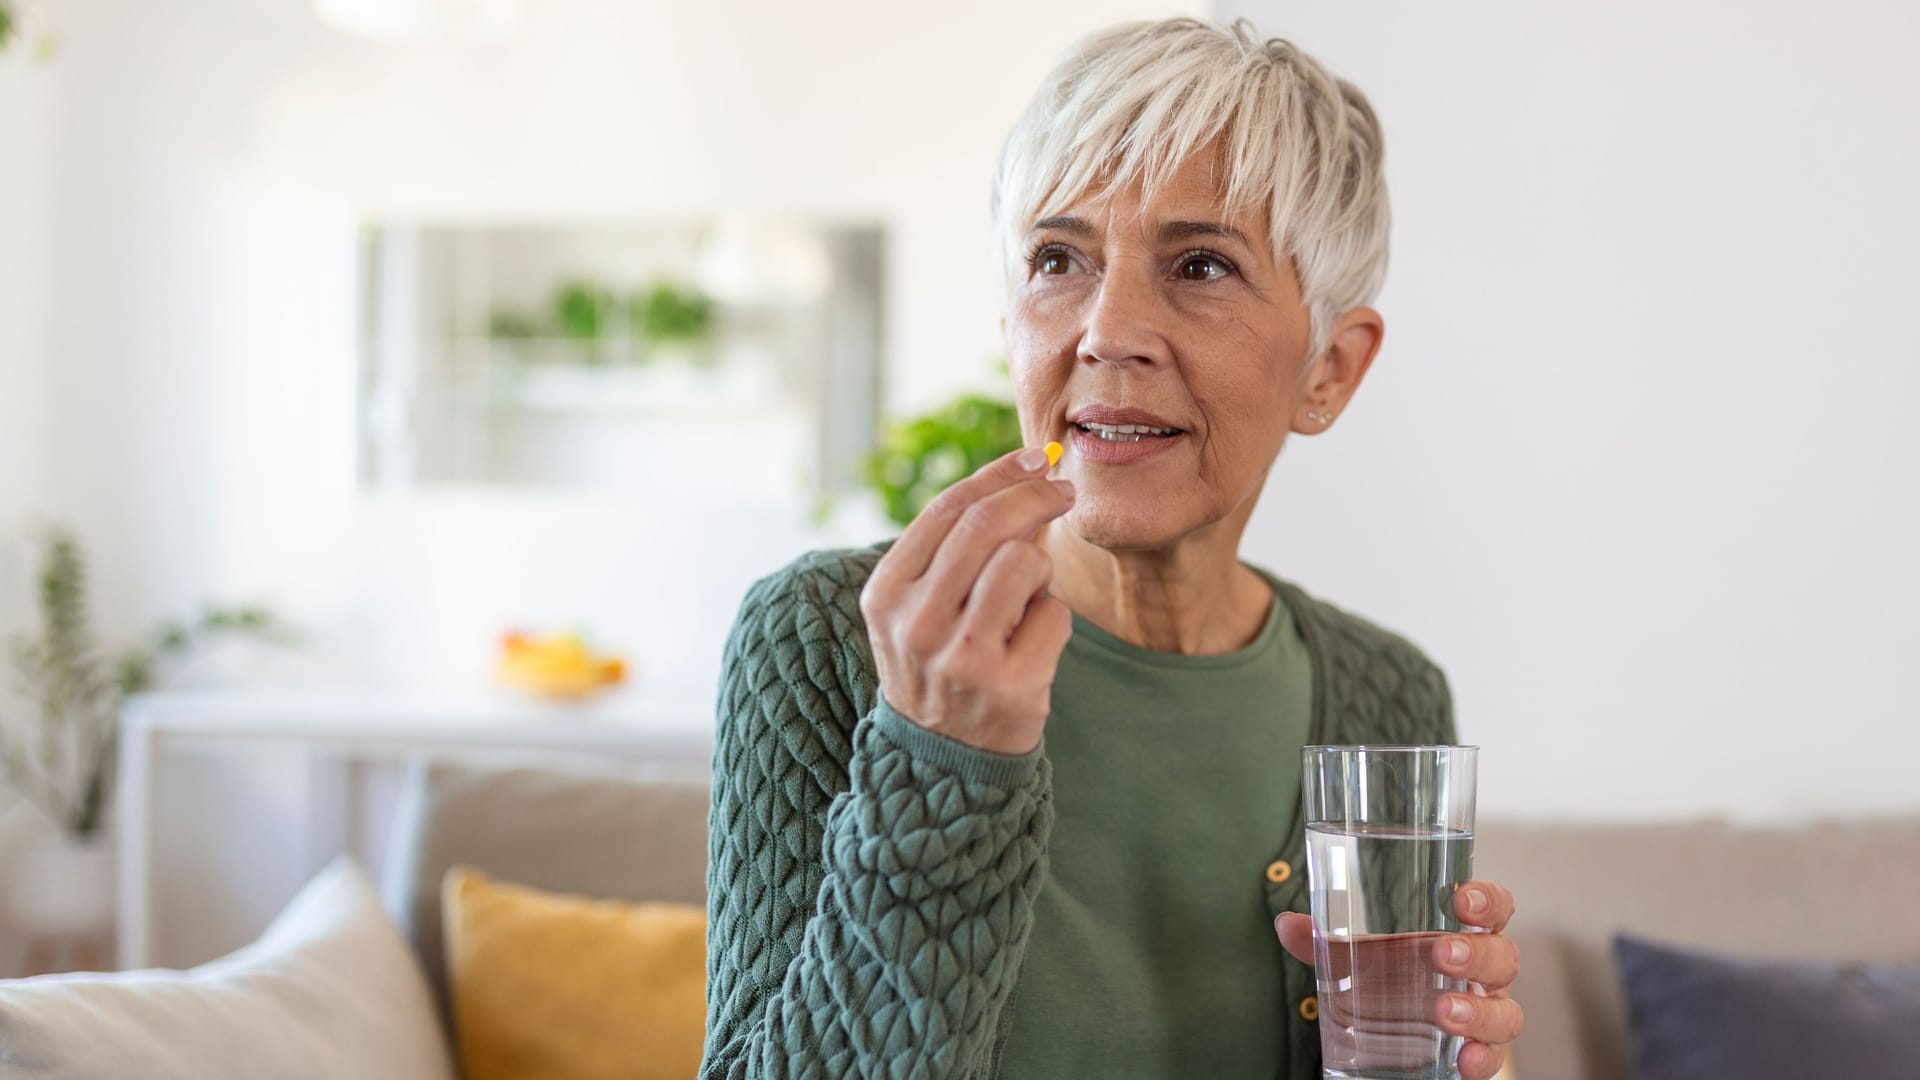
701, 544, 1453, 1080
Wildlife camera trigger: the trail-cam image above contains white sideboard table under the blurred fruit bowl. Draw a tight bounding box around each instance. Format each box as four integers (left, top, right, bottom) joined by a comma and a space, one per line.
115, 692, 712, 969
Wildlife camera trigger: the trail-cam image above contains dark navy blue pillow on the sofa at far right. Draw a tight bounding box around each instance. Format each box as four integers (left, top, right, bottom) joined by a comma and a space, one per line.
1613, 936, 1920, 1080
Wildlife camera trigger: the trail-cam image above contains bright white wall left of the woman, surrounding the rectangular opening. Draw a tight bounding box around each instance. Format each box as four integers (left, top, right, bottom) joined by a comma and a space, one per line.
0, 0, 1179, 701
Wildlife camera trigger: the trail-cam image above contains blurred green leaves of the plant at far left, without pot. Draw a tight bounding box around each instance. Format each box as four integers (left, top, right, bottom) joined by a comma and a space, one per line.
0, 527, 298, 840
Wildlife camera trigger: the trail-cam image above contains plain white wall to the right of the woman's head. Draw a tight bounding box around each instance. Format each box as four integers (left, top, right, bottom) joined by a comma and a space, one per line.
1219, 0, 1920, 819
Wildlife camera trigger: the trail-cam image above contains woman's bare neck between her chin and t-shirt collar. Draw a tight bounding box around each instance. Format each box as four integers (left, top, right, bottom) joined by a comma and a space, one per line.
1043, 515, 1273, 655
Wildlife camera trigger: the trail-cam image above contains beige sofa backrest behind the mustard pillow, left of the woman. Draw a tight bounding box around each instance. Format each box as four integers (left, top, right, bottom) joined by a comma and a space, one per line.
382, 761, 708, 1030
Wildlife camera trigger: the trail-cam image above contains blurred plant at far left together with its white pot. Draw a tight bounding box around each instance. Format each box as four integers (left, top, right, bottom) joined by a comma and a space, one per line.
0, 527, 292, 968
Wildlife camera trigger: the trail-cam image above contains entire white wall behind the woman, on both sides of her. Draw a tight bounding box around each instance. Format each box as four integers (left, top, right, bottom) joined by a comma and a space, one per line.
0, 0, 1920, 883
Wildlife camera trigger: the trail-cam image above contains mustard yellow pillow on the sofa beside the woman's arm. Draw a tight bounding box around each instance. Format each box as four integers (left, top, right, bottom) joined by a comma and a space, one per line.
442, 867, 707, 1080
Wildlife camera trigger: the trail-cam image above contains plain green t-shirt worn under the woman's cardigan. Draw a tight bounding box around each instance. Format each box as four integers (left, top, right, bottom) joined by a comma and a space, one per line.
1002, 580, 1313, 1080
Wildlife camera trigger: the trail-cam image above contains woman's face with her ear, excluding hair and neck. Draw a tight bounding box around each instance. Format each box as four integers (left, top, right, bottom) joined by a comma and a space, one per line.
1004, 152, 1379, 550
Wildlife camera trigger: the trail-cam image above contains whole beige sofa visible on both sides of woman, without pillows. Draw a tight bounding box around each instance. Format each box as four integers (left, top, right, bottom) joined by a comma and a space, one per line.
0, 761, 1920, 1080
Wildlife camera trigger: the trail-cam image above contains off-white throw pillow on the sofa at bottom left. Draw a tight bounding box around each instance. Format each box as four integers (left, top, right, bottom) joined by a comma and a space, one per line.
0, 857, 453, 1080
